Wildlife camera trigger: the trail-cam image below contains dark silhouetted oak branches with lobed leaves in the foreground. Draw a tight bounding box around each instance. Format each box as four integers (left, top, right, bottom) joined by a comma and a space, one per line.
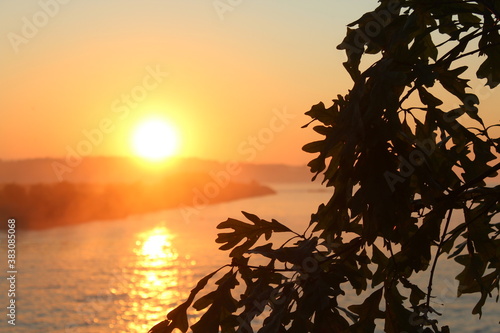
151, 0, 500, 333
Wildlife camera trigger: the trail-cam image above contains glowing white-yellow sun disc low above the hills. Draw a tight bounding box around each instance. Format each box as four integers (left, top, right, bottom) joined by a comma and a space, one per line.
132, 118, 179, 161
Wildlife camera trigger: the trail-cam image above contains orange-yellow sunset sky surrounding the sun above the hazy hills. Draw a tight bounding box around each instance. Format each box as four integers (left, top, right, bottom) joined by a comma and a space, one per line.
0, 0, 500, 164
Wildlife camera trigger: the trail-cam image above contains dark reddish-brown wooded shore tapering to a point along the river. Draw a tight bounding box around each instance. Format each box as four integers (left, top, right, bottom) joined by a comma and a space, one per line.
0, 174, 274, 229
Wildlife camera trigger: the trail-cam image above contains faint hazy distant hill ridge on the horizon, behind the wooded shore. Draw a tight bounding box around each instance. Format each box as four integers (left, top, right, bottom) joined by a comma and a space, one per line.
0, 157, 311, 184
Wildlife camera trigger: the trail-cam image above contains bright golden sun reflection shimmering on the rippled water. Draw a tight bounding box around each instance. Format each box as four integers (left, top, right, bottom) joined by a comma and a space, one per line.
111, 227, 195, 332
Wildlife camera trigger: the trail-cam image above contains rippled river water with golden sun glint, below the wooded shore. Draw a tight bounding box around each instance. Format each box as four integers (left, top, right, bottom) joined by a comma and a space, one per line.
0, 184, 500, 333
